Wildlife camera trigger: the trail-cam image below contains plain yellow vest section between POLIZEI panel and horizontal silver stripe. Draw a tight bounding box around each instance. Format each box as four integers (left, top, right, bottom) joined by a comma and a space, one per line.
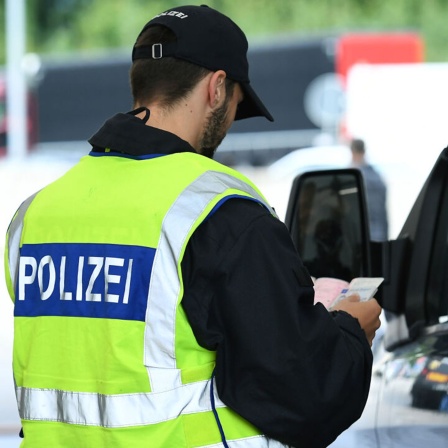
14, 316, 150, 394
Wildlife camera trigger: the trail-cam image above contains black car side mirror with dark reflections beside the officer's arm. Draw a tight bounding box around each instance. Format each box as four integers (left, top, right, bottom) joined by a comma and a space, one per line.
285, 168, 371, 281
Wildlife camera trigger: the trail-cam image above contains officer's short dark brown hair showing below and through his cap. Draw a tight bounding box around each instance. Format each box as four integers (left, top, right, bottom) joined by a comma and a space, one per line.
130, 25, 235, 107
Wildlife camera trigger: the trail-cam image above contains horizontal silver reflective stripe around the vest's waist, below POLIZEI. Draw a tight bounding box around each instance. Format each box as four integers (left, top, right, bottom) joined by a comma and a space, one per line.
16, 381, 224, 428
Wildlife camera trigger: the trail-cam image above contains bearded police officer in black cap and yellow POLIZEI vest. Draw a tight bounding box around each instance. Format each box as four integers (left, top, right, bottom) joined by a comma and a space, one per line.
6, 6, 380, 448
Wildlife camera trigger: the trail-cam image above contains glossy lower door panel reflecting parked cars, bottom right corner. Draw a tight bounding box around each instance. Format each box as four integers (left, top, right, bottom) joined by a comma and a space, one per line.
377, 333, 448, 448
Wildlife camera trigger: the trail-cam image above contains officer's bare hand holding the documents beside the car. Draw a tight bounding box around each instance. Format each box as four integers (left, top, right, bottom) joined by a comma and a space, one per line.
331, 294, 381, 346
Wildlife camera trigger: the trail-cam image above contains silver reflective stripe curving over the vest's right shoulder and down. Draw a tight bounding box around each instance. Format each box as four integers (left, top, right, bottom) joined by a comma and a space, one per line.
144, 171, 275, 391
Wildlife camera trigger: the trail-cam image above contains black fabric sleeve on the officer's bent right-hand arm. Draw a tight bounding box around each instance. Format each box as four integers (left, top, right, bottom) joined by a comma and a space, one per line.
182, 199, 372, 448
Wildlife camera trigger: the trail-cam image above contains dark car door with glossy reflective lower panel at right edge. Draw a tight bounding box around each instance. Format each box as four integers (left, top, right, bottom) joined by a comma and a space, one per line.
376, 149, 448, 448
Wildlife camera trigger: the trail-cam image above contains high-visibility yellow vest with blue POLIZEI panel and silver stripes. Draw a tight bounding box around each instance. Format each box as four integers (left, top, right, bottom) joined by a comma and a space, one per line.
5, 153, 288, 448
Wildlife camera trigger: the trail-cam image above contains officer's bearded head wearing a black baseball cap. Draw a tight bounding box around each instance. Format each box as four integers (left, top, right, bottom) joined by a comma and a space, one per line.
130, 6, 272, 156
